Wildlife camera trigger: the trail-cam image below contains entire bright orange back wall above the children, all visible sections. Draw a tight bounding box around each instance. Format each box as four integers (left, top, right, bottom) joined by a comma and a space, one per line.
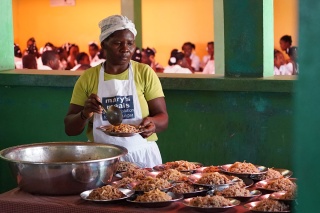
12, 0, 298, 65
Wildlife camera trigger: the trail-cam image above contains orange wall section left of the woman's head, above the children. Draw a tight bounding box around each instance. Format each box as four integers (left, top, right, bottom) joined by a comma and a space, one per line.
12, 0, 121, 55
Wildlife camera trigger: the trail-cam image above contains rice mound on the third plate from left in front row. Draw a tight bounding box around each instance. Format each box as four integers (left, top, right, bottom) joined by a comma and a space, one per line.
190, 195, 232, 208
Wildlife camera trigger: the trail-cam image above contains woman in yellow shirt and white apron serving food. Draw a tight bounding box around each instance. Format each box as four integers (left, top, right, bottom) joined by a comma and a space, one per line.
64, 15, 168, 167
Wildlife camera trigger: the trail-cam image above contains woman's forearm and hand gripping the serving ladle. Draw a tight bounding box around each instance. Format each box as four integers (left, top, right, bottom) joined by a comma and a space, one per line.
64, 94, 102, 136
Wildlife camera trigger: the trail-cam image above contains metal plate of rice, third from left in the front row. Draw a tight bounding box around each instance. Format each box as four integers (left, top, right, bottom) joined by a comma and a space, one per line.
182, 195, 240, 212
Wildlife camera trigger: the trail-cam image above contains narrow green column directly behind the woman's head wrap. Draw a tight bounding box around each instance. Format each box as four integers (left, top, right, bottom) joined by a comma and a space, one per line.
121, 0, 142, 48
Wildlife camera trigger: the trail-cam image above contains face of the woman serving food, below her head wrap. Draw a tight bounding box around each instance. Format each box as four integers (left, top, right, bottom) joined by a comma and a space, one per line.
102, 29, 136, 65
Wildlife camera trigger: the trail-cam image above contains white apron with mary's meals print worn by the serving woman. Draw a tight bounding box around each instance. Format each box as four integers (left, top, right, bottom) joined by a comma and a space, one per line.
93, 64, 162, 168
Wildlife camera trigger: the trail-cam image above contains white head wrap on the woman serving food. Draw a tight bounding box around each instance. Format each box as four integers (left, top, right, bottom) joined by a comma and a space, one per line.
99, 15, 137, 42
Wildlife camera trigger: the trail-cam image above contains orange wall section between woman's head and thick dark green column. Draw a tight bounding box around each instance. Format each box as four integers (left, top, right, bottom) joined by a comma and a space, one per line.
142, 0, 214, 66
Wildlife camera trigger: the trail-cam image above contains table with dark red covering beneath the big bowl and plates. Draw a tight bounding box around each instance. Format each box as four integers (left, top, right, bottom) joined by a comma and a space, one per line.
0, 188, 250, 213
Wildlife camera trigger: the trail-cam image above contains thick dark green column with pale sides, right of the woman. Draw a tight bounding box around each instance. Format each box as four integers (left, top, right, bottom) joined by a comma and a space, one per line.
214, 0, 274, 77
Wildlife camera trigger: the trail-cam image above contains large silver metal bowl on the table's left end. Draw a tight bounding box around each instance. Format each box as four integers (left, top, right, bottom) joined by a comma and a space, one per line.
0, 142, 128, 195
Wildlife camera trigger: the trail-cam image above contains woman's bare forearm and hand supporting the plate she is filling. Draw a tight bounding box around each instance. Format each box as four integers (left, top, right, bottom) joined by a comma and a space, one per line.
141, 97, 169, 138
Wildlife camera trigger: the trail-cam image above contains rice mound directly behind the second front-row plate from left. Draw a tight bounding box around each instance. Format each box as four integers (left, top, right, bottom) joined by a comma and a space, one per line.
133, 177, 171, 192
